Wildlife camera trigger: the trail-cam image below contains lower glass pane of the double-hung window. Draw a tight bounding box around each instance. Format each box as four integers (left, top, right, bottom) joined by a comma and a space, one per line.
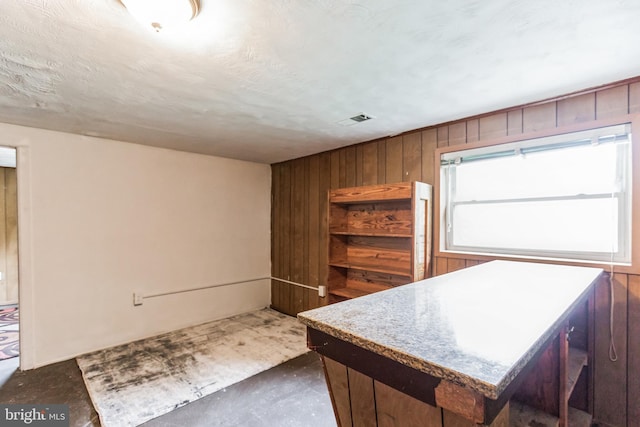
452, 198, 618, 253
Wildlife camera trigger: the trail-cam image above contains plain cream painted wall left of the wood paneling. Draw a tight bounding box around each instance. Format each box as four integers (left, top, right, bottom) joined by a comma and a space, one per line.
0, 124, 271, 369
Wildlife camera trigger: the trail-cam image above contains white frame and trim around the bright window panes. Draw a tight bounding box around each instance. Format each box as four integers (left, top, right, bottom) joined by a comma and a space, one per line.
434, 115, 640, 272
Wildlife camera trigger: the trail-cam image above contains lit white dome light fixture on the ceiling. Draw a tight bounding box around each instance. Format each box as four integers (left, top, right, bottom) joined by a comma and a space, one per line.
120, 0, 200, 32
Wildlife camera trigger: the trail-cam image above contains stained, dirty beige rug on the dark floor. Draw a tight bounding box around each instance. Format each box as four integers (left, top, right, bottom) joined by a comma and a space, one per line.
77, 309, 307, 427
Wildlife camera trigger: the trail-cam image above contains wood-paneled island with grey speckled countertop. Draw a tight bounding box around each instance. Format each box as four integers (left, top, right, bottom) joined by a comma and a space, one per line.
298, 261, 602, 427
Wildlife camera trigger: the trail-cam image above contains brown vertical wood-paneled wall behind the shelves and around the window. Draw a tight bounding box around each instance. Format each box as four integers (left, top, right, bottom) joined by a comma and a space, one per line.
271, 78, 640, 426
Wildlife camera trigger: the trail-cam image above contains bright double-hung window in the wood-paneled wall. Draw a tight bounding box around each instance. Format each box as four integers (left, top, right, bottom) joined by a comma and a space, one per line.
440, 124, 632, 265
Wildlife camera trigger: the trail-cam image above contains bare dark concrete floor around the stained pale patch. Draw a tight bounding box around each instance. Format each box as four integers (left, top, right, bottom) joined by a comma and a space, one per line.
0, 352, 336, 427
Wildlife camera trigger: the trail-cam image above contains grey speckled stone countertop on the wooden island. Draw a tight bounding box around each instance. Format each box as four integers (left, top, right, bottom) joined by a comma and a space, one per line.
298, 261, 602, 399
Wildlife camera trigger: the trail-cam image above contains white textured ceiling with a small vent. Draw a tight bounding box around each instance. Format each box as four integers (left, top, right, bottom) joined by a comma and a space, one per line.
0, 0, 640, 163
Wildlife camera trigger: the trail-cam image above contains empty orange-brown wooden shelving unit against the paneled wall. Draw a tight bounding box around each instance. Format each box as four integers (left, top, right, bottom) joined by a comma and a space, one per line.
327, 182, 432, 302
